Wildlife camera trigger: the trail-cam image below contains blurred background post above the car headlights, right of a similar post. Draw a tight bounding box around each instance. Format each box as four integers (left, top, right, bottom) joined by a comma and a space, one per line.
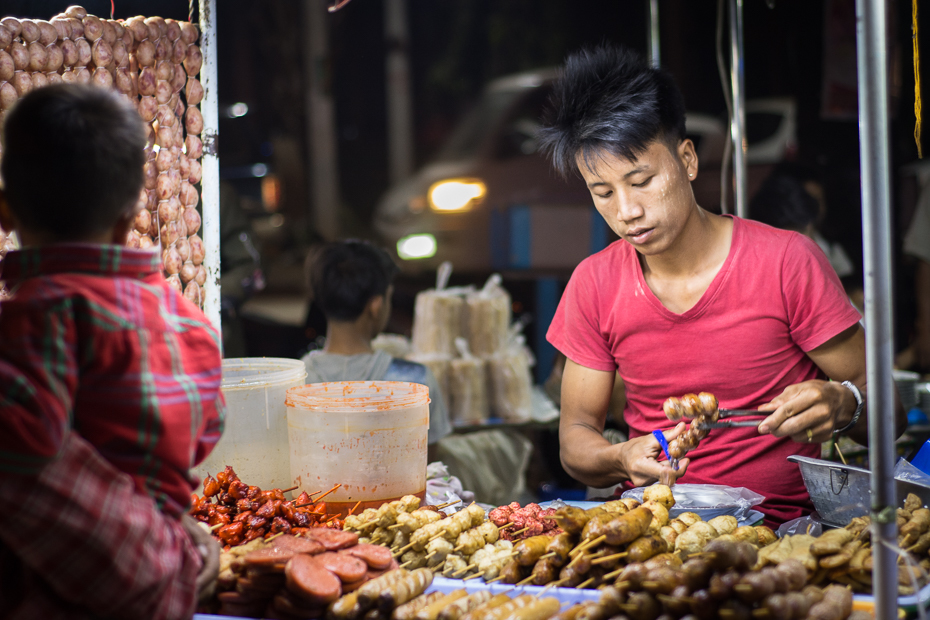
384, 0, 413, 183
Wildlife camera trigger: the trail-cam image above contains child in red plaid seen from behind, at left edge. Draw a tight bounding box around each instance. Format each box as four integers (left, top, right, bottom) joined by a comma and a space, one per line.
0, 85, 224, 618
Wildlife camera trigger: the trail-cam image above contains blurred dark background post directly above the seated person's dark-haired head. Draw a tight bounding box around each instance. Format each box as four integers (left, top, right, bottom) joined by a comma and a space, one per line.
303, 0, 339, 241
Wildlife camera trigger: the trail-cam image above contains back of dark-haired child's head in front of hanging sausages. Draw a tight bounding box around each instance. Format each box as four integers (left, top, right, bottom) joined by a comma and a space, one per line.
0, 84, 147, 241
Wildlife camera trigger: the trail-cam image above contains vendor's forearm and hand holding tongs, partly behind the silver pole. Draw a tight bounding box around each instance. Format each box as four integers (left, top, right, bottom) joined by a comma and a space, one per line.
759, 324, 907, 445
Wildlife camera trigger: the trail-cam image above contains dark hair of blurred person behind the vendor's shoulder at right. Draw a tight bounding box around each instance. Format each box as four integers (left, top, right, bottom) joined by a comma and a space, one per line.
749, 165, 820, 232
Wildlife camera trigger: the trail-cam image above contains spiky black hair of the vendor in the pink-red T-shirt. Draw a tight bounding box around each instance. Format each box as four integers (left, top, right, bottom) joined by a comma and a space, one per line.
540, 46, 685, 177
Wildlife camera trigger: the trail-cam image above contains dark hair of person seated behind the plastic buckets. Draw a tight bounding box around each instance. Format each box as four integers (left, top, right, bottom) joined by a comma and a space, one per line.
309, 240, 398, 321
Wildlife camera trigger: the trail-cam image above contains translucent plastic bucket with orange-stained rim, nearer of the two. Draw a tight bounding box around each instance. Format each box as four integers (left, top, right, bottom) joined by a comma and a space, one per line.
286, 381, 430, 515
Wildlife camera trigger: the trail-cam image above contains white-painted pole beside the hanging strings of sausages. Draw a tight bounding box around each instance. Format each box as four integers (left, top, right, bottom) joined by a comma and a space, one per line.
200, 0, 222, 334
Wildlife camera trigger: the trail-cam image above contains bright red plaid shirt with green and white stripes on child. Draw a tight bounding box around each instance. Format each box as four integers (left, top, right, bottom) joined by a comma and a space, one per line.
0, 244, 225, 516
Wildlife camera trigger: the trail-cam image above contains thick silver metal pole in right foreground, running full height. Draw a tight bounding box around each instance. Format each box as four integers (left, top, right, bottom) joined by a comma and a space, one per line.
856, 0, 898, 620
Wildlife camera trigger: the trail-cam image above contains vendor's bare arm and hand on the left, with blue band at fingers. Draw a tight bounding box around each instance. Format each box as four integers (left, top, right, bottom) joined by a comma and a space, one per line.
559, 359, 688, 488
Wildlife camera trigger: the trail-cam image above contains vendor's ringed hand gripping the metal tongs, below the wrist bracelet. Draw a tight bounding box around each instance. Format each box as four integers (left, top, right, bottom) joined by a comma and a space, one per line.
759, 380, 856, 443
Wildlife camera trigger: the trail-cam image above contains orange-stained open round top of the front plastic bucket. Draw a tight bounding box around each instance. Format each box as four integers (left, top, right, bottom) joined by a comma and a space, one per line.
284, 381, 430, 413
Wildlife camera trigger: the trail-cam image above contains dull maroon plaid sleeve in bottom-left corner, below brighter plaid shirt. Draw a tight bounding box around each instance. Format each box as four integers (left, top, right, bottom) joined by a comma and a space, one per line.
0, 433, 202, 620
